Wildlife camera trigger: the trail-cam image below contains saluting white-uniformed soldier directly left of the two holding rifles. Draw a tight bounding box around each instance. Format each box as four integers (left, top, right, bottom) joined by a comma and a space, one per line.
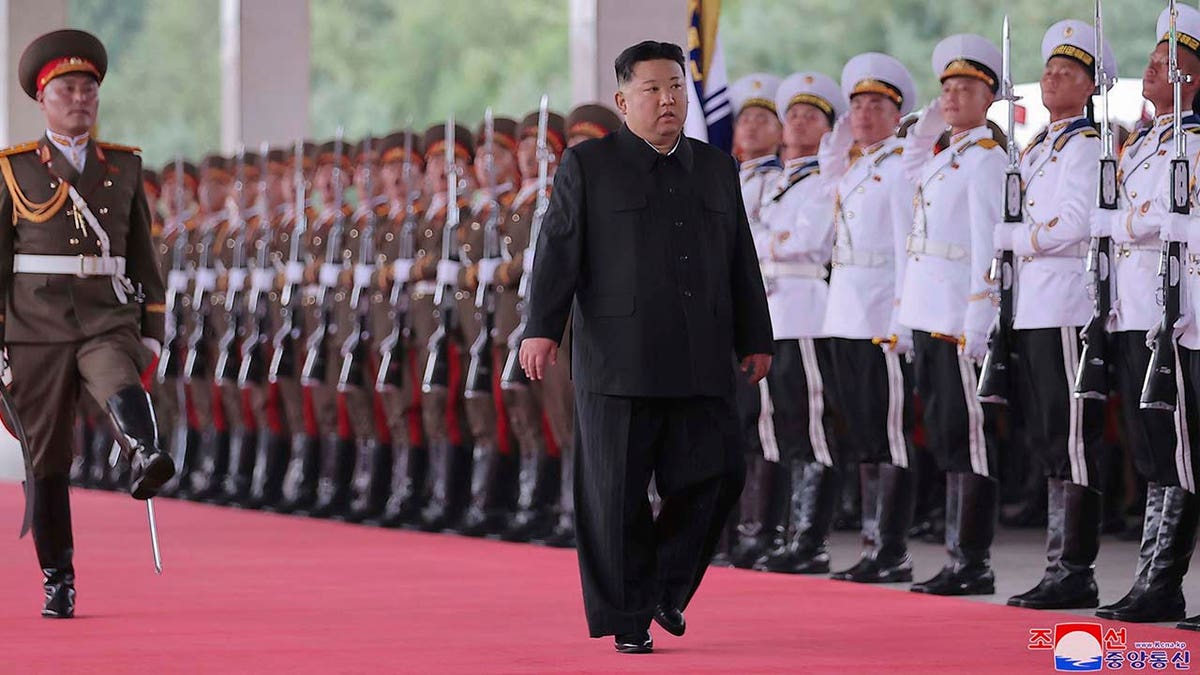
900, 35, 1007, 596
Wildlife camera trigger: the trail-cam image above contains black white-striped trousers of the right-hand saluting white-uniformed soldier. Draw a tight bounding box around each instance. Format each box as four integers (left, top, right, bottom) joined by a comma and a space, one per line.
912, 330, 998, 478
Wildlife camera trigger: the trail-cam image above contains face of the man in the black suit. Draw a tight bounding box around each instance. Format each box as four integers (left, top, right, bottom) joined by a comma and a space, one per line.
616, 59, 688, 145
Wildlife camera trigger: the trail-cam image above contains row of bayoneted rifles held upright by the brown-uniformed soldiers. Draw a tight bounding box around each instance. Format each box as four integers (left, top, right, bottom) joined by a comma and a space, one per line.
157, 95, 550, 398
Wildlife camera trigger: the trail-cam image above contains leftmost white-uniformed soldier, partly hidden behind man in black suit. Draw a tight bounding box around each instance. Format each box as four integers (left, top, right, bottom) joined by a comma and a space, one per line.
715, 73, 787, 567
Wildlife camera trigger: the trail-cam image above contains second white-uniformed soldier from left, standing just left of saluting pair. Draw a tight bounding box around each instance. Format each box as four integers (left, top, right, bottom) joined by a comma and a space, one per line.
755, 72, 848, 574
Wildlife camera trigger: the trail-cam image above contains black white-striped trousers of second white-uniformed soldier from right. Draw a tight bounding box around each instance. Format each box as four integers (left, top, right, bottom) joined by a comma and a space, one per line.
1014, 327, 1104, 489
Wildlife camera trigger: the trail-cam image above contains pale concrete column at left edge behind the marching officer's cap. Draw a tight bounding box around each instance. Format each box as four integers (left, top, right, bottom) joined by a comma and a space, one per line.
0, 0, 67, 148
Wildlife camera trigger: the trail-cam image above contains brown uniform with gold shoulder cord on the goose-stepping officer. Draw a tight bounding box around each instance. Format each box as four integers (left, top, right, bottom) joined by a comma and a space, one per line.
0, 138, 166, 478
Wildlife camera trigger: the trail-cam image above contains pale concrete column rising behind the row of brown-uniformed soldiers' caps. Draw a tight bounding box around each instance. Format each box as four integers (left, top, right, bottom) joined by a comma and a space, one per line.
221, 0, 310, 154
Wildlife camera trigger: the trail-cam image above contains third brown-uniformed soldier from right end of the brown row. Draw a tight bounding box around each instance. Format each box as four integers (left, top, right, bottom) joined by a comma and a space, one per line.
455, 117, 526, 537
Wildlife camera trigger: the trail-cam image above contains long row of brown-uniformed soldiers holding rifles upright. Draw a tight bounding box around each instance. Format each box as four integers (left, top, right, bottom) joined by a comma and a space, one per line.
72, 104, 620, 546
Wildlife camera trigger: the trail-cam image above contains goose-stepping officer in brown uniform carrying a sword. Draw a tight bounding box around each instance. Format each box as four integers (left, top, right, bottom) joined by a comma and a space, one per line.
0, 30, 175, 619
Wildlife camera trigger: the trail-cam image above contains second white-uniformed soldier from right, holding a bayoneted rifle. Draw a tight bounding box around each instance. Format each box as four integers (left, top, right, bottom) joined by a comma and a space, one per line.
995, 19, 1116, 609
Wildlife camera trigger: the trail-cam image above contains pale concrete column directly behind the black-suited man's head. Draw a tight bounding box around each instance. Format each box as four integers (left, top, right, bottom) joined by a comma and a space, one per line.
559, 0, 688, 107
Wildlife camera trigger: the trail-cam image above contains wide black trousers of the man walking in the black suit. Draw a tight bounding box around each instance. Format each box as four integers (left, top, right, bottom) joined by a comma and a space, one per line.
575, 390, 745, 638
